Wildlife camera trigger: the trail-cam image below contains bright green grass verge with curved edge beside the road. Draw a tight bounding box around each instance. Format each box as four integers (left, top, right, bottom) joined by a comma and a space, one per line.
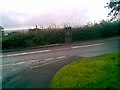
50, 53, 120, 88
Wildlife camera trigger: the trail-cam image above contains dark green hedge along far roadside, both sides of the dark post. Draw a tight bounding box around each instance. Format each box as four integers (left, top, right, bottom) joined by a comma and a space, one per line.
0, 21, 120, 50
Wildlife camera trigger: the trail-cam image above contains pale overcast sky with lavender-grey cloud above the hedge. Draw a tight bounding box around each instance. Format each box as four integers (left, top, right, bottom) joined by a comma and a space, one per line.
0, 0, 110, 29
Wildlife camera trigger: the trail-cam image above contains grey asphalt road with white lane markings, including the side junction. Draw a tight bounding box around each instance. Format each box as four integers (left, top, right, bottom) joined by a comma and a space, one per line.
0, 37, 119, 88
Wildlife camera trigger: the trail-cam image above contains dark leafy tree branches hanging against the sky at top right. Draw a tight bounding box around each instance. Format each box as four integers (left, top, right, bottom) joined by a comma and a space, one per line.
105, 0, 120, 21
